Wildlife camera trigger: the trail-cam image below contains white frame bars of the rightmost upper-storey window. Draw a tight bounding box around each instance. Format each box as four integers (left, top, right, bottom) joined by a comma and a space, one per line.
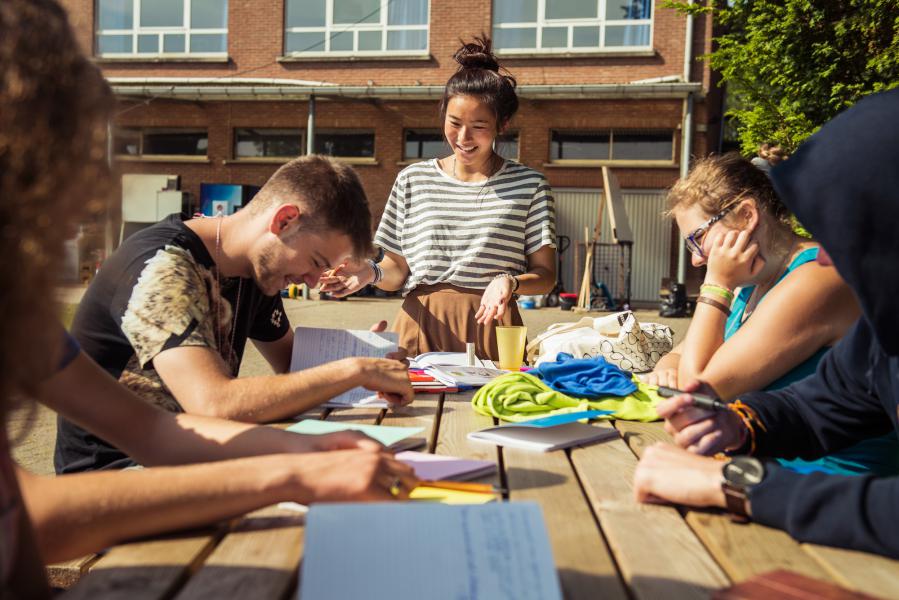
491, 0, 656, 56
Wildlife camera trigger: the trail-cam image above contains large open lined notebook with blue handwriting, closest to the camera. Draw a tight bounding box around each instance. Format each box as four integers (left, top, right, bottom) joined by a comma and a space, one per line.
297, 502, 562, 600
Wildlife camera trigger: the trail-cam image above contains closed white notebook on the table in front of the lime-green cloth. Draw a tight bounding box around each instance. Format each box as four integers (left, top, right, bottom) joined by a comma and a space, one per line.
468, 422, 618, 452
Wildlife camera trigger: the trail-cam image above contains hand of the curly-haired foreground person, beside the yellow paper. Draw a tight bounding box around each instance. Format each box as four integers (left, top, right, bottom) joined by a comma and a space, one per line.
292, 449, 418, 504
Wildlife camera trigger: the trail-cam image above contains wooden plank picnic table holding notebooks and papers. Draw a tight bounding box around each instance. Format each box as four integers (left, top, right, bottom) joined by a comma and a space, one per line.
58, 393, 899, 600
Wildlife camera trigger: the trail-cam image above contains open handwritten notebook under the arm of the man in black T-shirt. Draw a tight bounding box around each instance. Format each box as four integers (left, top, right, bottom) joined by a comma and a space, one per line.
290, 327, 399, 408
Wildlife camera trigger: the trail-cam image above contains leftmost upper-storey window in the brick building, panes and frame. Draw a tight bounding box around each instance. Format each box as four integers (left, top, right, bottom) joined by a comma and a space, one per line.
96, 0, 228, 58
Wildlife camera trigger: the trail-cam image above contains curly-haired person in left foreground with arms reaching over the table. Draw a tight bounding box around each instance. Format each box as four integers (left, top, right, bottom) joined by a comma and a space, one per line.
0, 0, 413, 598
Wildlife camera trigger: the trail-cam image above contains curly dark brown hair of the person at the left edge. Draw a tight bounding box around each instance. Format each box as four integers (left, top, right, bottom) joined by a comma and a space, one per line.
0, 0, 114, 411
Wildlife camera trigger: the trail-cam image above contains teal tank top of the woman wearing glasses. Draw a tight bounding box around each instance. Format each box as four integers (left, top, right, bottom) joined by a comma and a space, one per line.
724, 248, 899, 476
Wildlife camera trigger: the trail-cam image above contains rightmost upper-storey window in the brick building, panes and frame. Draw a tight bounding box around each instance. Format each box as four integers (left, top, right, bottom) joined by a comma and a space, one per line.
493, 0, 652, 53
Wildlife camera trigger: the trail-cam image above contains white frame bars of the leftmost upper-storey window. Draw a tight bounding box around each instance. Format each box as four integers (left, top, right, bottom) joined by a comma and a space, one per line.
94, 0, 229, 60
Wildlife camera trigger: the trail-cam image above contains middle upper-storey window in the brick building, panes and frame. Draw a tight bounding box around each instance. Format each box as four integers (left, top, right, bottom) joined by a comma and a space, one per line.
284, 0, 428, 56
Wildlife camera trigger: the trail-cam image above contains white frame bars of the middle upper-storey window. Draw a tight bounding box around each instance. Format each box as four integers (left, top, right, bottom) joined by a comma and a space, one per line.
282, 0, 431, 59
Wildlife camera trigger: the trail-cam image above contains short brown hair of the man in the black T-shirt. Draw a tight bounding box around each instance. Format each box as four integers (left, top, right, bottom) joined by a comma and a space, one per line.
249, 154, 374, 257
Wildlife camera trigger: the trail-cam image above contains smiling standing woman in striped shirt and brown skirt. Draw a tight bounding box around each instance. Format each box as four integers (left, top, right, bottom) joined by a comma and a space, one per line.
322, 38, 556, 360
